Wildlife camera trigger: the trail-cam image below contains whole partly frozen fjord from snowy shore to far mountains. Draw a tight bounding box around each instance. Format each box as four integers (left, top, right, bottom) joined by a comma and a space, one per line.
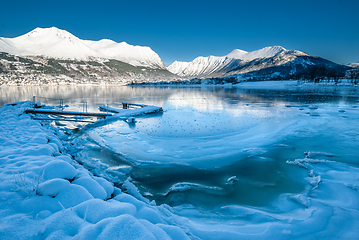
0, 82, 359, 239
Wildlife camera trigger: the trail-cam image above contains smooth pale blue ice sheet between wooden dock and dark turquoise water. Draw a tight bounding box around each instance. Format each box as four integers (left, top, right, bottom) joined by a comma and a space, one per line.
89, 100, 305, 168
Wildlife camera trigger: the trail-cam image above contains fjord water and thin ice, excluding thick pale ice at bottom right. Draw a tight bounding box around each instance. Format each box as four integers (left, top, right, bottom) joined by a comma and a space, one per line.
0, 86, 359, 209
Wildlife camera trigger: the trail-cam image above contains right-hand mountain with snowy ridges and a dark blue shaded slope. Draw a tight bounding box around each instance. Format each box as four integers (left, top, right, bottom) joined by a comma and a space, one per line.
168, 46, 349, 78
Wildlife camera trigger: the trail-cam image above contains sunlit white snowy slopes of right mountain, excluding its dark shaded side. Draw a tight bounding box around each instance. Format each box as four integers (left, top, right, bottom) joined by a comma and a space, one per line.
167, 46, 308, 77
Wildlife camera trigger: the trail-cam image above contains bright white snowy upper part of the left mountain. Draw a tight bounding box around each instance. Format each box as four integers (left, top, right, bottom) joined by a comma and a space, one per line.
0, 27, 165, 69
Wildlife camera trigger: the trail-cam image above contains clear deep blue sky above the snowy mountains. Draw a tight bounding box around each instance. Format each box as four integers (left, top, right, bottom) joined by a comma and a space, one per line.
0, 0, 359, 65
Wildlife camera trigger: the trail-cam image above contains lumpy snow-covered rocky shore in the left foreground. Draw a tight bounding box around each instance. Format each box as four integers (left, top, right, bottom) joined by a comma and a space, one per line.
0, 102, 191, 239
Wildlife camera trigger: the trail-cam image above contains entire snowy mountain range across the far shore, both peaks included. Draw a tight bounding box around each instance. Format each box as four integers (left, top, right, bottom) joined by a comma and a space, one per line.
0, 27, 356, 81
